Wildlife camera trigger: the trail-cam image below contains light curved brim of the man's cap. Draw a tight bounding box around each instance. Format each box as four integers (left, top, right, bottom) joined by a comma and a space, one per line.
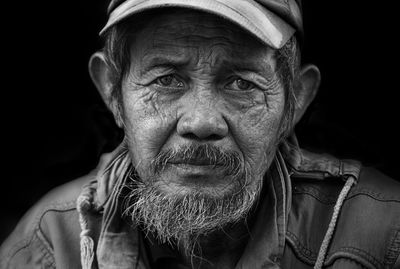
100, 0, 295, 49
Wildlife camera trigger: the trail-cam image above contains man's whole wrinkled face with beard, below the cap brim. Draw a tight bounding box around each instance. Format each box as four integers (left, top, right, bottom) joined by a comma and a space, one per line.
120, 11, 285, 242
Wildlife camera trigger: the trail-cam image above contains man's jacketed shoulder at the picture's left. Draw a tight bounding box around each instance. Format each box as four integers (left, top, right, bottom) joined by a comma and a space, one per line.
0, 175, 93, 268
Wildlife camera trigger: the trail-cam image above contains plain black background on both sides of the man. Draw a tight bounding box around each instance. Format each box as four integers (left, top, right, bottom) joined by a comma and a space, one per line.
0, 0, 400, 242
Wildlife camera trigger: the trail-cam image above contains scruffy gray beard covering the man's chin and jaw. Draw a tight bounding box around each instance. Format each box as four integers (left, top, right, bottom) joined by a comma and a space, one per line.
124, 168, 262, 257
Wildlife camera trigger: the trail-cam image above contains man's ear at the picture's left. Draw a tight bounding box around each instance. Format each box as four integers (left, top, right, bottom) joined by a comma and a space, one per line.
89, 52, 122, 127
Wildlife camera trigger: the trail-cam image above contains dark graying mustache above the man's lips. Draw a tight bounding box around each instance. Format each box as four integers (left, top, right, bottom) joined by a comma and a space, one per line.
152, 144, 242, 176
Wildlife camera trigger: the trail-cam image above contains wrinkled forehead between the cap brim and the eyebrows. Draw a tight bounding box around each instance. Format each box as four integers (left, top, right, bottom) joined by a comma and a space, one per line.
131, 10, 275, 73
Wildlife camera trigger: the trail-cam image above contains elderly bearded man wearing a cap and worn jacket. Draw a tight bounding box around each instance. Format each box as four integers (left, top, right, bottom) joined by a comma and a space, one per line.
1, 0, 400, 268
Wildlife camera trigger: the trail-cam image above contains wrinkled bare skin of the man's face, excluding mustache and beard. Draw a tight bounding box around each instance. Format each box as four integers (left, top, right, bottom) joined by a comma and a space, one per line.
121, 12, 285, 196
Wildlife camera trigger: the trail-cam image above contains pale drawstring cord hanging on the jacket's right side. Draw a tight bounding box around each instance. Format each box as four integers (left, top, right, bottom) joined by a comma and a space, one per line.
314, 176, 356, 269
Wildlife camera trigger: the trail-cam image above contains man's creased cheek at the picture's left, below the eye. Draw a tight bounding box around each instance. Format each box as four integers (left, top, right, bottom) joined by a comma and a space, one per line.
122, 88, 176, 164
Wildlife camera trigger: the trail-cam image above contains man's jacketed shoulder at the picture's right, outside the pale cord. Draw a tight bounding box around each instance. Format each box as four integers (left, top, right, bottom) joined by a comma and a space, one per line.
330, 167, 400, 268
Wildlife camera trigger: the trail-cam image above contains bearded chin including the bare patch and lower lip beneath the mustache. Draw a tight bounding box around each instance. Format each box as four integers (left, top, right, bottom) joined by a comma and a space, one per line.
123, 160, 261, 250
